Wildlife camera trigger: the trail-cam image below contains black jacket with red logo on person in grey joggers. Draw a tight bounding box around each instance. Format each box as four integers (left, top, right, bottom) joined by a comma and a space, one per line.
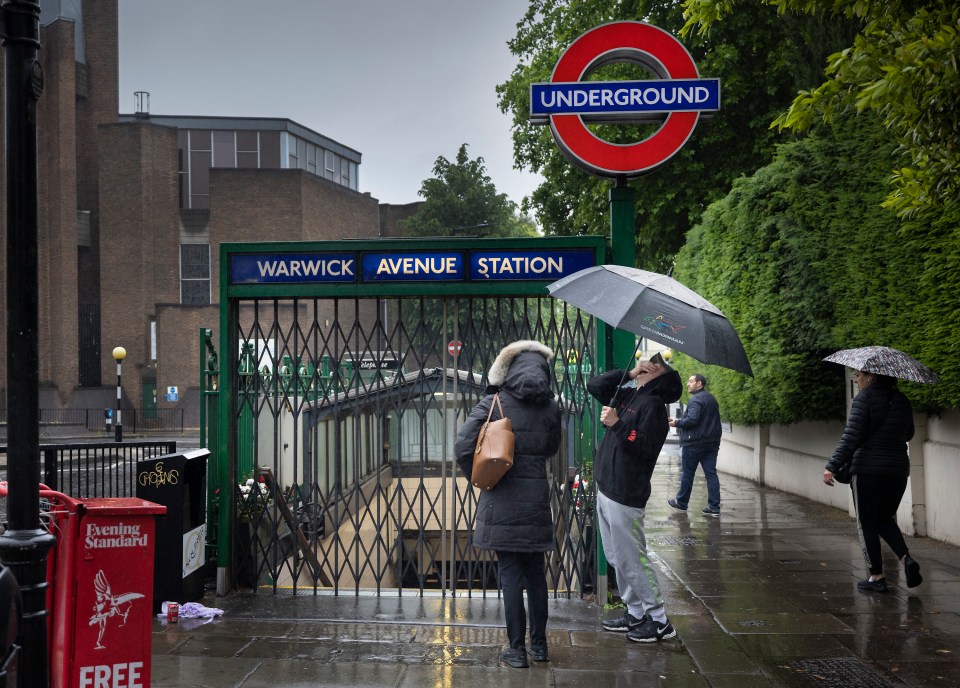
587, 370, 683, 509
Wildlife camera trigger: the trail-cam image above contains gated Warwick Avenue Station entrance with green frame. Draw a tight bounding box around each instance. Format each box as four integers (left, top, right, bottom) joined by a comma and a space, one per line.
214, 237, 605, 596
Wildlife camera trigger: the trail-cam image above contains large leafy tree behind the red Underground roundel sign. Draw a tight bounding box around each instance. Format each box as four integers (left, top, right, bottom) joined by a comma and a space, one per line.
497, 0, 854, 271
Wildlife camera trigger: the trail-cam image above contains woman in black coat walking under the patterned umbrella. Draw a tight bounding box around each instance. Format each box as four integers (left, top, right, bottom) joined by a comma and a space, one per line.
823, 370, 923, 592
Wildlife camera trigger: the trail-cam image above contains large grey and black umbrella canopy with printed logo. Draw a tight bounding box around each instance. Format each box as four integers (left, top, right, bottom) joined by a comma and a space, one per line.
547, 265, 753, 376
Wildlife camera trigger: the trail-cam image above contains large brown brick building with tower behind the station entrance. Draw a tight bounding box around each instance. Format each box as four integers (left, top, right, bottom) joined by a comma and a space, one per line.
0, 0, 419, 425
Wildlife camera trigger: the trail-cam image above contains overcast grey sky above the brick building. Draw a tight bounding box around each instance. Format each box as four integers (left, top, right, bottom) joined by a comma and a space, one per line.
120, 0, 539, 208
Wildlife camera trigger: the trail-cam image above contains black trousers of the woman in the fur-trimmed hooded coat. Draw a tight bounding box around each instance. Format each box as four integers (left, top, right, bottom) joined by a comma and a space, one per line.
497, 550, 547, 650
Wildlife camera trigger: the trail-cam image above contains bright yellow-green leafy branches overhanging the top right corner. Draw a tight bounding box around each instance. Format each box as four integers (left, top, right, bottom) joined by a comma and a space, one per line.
683, 0, 960, 217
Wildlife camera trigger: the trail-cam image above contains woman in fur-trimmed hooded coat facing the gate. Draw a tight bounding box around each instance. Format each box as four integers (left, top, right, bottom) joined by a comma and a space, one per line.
454, 341, 560, 668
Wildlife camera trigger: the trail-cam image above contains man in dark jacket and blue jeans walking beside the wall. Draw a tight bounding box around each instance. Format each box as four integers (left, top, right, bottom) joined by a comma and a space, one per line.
667, 373, 723, 516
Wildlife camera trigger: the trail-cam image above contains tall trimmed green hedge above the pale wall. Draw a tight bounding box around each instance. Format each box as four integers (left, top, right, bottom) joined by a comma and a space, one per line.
674, 115, 960, 424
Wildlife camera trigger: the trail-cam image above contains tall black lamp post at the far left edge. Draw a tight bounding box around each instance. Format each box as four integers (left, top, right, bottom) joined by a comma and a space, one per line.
0, 0, 56, 687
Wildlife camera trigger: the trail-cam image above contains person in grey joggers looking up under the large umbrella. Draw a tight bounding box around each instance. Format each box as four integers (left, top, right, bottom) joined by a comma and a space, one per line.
587, 354, 682, 643
